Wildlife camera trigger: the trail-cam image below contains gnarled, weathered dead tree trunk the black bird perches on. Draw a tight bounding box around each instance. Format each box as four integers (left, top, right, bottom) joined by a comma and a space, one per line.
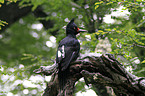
34, 54, 145, 96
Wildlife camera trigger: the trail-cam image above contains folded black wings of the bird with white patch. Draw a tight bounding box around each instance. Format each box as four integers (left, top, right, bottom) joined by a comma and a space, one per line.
56, 40, 79, 71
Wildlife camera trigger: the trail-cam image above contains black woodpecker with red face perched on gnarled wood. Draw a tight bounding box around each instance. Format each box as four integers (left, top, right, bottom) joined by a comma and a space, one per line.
56, 19, 85, 90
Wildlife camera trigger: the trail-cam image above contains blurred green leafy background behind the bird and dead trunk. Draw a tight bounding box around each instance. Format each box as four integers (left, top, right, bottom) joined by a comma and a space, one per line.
0, 0, 145, 96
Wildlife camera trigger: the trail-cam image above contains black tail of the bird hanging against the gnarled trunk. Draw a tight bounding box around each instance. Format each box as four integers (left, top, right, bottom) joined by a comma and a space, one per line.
58, 68, 69, 90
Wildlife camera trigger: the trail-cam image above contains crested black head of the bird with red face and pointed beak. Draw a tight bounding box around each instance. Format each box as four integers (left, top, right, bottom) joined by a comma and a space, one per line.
66, 18, 86, 35
